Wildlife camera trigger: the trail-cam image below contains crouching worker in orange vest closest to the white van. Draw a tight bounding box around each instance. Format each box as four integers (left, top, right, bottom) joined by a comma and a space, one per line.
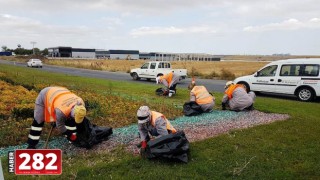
222, 81, 256, 111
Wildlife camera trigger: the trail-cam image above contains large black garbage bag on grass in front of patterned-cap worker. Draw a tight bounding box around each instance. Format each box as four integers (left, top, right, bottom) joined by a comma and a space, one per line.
146, 131, 189, 163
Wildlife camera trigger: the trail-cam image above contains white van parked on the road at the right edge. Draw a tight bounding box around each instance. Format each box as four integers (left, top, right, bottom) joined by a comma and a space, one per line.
234, 58, 320, 101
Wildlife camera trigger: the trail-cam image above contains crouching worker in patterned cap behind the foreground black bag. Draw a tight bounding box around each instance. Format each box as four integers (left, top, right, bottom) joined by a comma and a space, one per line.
137, 106, 177, 156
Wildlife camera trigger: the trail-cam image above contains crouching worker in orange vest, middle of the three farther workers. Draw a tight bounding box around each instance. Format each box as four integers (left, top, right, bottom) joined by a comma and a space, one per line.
188, 80, 215, 112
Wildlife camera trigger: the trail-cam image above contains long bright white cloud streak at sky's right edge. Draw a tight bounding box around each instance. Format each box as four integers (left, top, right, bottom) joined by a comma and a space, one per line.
243, 18, 320, 32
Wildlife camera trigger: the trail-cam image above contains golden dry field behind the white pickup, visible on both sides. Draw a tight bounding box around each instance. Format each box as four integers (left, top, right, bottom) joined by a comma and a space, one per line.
45, 59, 268, 77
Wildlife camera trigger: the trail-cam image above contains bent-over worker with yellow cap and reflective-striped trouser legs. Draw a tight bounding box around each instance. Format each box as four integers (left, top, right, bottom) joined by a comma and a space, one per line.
27, 87, 86, 149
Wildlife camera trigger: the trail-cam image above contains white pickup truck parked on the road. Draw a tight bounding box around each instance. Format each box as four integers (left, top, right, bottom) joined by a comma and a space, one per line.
130, 61, 187, 80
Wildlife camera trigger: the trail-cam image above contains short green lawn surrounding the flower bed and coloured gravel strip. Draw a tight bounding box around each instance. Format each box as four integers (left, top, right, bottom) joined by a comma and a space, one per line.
0, 65, 320, 179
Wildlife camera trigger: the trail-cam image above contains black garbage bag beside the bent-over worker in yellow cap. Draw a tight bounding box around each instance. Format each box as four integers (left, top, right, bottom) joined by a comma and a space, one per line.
73, 118, 112, 149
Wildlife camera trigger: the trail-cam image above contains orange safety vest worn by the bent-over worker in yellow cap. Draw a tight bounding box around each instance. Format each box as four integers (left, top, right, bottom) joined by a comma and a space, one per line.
45, 87, 84, 122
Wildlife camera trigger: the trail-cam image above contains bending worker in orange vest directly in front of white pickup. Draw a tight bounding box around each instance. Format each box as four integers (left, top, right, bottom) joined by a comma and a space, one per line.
156, 72, 180, 97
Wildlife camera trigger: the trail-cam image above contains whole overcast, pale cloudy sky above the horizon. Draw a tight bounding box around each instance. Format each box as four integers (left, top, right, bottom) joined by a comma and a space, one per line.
0, 0, 320, 55
